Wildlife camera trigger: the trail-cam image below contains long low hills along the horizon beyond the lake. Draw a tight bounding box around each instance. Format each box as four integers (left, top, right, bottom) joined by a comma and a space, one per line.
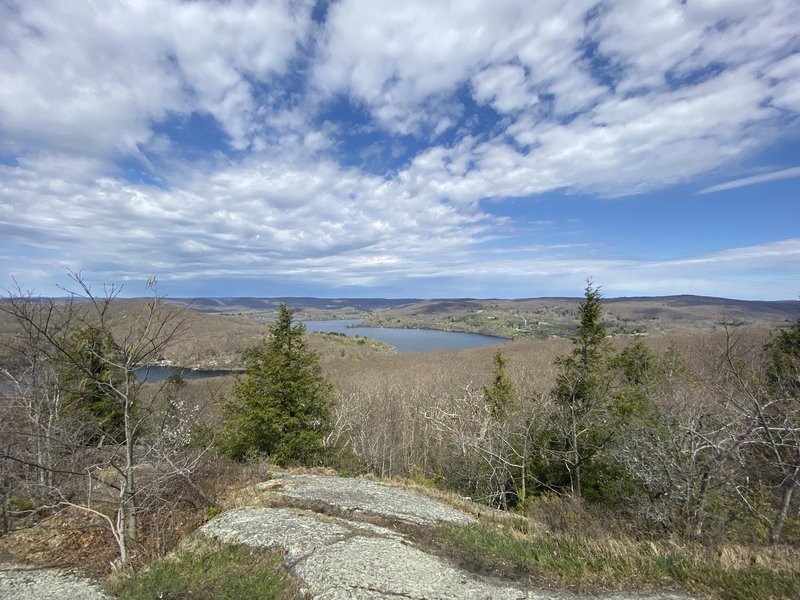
159, 295, 800, 338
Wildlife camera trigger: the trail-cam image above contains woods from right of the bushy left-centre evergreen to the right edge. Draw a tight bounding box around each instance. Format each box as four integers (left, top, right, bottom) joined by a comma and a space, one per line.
328, 284, 800, 543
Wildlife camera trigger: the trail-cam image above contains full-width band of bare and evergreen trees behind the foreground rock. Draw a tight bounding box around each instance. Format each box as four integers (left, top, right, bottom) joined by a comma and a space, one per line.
0, 274, 800, 564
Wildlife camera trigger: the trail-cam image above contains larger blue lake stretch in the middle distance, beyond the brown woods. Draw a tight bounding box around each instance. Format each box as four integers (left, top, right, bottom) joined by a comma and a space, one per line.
304, 319, 508, 352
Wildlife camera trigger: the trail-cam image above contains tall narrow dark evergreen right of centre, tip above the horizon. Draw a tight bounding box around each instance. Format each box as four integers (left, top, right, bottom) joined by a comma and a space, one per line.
553, 279, 613, 498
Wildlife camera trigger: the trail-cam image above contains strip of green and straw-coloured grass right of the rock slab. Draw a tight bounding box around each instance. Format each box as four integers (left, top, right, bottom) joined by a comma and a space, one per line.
438, 525, 800, 600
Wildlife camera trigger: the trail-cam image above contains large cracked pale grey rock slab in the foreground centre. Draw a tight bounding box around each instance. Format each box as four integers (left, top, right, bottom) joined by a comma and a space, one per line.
201, 475, 685, 600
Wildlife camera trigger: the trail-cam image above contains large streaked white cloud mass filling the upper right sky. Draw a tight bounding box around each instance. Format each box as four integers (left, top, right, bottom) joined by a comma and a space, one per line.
316, 0, 800, 196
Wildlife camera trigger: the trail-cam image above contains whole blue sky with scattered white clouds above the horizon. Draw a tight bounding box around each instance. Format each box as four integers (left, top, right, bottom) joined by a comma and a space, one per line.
0, 0, 800, 300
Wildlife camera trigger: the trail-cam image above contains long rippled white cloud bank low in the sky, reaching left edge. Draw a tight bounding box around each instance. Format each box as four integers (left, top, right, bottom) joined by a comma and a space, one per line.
0, 151, 490, 282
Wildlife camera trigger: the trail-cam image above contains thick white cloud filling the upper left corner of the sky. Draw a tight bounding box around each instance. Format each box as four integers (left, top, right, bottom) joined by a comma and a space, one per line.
0, 0, 311, 157
